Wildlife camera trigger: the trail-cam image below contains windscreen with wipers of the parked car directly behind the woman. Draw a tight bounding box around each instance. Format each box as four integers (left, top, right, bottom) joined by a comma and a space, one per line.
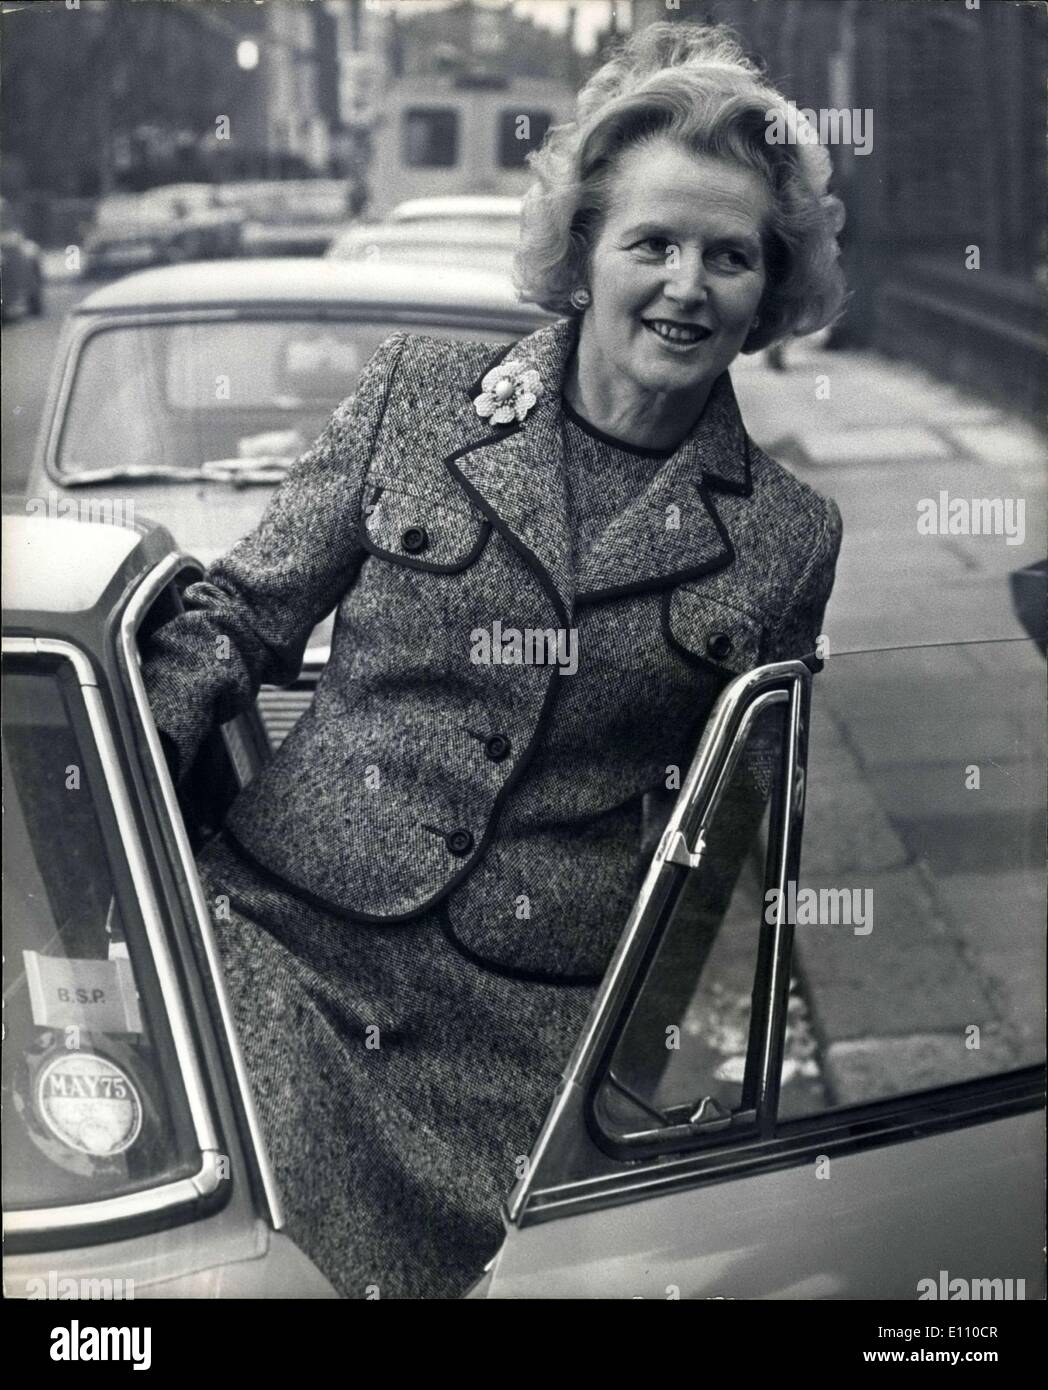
56, 316, 520, 478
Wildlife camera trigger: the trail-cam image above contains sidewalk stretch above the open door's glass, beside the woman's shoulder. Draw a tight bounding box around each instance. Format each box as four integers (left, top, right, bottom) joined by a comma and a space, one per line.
732, 342, 1048, 651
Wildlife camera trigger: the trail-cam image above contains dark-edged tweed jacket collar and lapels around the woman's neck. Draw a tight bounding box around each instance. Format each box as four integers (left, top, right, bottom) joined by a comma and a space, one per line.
445, 318, 752, 626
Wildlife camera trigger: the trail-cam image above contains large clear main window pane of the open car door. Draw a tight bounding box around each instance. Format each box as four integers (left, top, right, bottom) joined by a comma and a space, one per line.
794, 641, 1045, 1106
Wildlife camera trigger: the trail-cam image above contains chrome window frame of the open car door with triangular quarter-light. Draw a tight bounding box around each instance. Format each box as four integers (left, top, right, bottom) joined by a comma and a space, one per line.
505, 660, 1045, 1227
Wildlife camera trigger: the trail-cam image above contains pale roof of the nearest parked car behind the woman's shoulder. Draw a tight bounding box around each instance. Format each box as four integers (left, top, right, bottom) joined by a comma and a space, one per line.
72, 256, 546, 321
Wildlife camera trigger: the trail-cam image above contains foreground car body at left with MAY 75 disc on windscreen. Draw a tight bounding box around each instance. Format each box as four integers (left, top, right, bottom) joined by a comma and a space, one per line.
3, 503, 332, 1297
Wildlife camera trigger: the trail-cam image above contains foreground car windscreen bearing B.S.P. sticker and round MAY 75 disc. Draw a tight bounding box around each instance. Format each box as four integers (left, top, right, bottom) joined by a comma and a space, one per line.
3, 655, 200, 1211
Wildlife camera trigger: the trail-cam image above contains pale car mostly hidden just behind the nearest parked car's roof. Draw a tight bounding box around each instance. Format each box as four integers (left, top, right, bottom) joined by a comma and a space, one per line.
327, 218, 518, 275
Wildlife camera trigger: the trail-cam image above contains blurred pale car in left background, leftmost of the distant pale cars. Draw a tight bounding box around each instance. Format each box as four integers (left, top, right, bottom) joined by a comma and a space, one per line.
82, 183, 243, 275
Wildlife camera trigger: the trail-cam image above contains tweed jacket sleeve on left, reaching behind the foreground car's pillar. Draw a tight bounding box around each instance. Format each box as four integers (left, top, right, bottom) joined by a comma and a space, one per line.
135, 334, 407, 780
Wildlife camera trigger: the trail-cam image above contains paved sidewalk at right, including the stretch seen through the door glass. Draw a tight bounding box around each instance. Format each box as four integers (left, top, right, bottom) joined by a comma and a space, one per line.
732, 345, 1045, 1104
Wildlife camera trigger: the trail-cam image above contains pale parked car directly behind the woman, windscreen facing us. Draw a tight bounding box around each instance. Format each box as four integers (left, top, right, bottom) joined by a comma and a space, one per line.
28, 259, 548, 741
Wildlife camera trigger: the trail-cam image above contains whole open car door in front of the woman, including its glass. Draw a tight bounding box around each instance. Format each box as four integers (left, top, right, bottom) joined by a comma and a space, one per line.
474, 641, 1045, 1300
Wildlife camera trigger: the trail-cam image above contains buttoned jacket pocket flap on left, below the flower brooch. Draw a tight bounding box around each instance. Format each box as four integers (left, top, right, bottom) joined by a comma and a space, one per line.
360, 484, 491, 574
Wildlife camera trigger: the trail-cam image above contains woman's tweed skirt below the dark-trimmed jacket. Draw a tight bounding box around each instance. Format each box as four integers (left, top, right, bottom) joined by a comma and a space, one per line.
197, 838, 595, 1298
